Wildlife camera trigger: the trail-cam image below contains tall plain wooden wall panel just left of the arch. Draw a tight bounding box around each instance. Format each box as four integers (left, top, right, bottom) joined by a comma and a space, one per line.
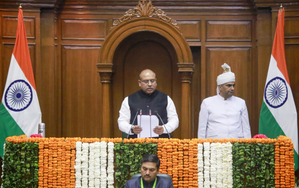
61, 46, 101, 137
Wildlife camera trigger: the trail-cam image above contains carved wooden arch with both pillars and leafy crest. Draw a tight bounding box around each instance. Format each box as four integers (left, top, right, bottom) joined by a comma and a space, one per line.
97, 0, 194, 138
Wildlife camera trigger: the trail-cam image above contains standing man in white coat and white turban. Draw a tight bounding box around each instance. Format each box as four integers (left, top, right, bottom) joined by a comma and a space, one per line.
198, 63, 251, 139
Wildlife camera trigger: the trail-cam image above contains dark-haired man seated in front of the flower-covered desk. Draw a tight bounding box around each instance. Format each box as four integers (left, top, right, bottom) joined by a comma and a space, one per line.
125, 154, 173, 188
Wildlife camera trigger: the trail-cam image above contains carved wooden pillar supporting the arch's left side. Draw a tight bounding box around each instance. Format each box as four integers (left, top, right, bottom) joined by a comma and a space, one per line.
97, 63, 113, 138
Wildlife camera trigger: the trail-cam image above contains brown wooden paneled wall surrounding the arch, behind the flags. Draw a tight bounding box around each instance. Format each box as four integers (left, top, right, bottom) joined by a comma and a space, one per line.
0, 1, 299, 141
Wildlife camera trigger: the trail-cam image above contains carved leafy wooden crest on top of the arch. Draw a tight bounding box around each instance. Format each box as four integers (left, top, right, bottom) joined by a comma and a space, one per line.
111, 0, 180, 30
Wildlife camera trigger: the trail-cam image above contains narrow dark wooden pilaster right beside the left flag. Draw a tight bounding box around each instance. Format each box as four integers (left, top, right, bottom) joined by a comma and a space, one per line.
36, 10, 56, 137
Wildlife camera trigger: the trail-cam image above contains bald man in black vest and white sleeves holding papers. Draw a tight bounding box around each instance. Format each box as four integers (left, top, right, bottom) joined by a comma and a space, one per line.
118, 69, 179, 138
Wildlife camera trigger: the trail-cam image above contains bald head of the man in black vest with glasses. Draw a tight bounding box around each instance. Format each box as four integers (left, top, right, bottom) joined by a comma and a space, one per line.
138, 69, 157, 95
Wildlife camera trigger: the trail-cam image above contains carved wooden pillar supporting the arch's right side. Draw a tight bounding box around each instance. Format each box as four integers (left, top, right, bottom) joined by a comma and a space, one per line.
178, 63, 194, 139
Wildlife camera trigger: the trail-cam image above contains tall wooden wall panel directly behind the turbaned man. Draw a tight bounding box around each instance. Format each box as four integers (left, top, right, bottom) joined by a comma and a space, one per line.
203, 46, 258, 134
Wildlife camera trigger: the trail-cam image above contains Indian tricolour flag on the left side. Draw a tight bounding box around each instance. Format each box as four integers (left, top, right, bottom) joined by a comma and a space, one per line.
0, 8, 41, 158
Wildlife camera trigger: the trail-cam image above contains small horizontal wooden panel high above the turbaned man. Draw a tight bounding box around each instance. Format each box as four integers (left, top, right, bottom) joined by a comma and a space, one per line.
206, 20, 252, 41
